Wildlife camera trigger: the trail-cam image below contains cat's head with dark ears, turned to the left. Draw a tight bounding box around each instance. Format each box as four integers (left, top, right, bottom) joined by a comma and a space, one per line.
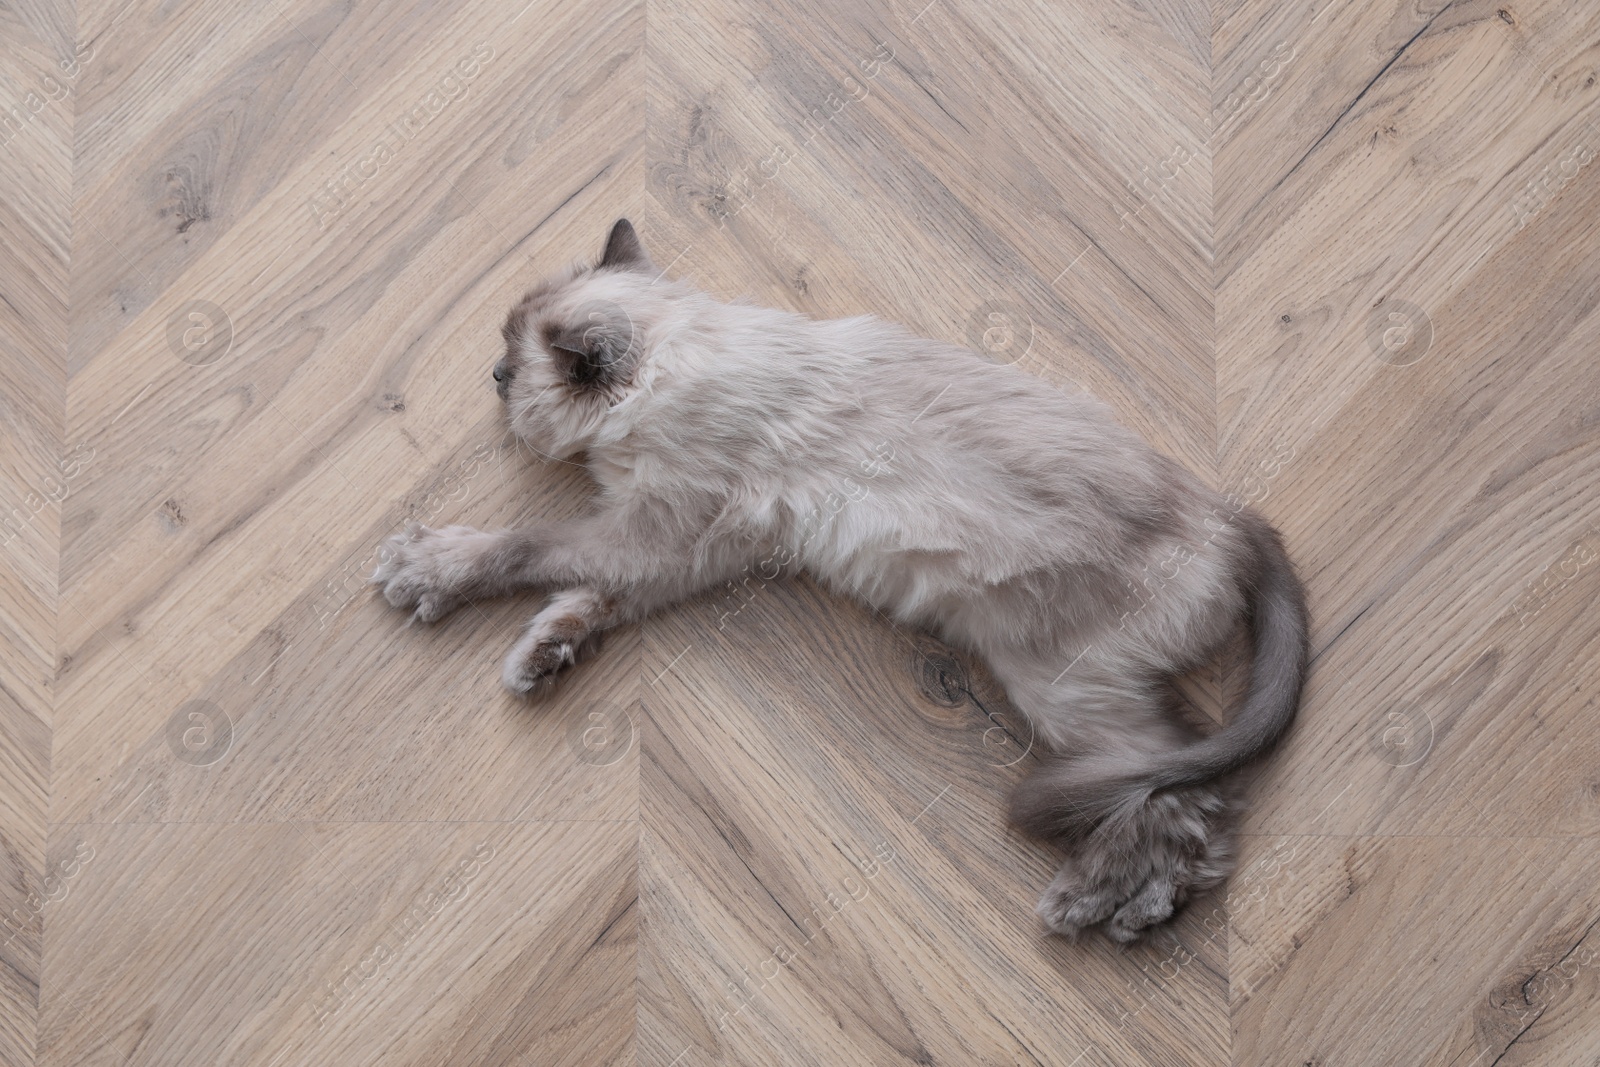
493, 219, 670, 458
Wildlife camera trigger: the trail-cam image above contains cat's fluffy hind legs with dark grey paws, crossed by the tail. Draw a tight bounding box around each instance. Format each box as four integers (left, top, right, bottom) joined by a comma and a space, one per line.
1013, 657, 1237, 942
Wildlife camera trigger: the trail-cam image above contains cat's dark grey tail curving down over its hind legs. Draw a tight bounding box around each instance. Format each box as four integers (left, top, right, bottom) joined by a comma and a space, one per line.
1011, 510, 1307, 841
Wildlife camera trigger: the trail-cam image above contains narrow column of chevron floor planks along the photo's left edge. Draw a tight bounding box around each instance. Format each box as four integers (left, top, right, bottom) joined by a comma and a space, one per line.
0, 2, 78, 1064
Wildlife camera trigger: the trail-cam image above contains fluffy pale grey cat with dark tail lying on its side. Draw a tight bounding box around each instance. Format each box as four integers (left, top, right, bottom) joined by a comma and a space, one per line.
373, 219, 1307, 942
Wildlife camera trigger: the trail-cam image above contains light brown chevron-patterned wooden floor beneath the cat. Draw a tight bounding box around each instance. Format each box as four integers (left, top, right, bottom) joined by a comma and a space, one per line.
0, 0, 1600, 1067
